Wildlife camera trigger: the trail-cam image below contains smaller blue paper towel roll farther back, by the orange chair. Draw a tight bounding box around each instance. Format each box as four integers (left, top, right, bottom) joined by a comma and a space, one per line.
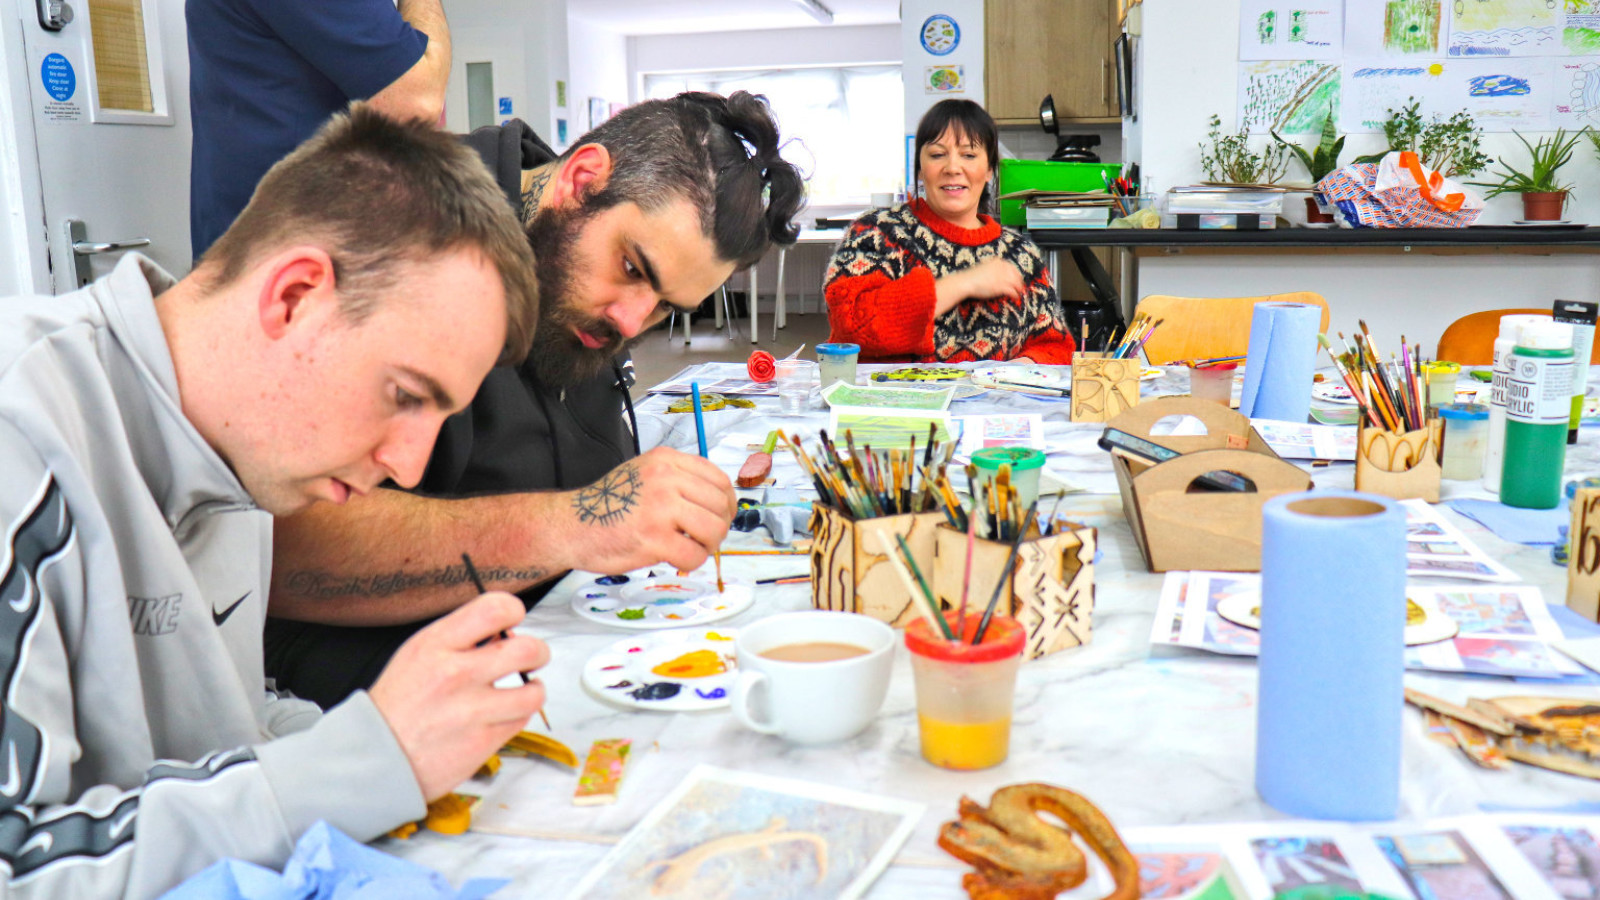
1238, 303, 1322, 421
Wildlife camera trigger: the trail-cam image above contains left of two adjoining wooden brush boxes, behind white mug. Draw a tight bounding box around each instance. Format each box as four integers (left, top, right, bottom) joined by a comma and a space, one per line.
811, 503, 946, 628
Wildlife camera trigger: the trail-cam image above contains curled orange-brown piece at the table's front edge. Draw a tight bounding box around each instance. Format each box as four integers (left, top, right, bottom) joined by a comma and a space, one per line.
939, 783, 1139, 900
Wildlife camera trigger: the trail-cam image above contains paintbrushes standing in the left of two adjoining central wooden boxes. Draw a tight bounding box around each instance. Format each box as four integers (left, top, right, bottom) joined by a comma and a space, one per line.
784, 426, 960, 519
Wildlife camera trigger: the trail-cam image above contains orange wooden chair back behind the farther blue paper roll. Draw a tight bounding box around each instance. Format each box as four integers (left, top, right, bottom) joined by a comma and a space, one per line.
1139, 291, 1328, 365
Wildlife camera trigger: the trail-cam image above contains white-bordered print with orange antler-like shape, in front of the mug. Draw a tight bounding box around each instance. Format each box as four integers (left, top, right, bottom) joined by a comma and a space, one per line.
571, 765, 922, 900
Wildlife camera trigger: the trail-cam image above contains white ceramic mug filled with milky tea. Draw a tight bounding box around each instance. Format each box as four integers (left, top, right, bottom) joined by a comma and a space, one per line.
733, 610, 896, 743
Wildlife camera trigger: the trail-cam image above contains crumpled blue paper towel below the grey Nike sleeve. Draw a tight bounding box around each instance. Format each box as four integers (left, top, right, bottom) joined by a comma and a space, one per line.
162, 822, 506, 900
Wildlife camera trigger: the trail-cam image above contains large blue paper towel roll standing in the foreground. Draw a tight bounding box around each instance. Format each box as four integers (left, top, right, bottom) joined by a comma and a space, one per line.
1256, 492, 1406, 820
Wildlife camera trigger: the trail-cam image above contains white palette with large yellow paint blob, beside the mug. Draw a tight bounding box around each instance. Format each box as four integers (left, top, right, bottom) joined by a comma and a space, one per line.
582, 628, 739, 713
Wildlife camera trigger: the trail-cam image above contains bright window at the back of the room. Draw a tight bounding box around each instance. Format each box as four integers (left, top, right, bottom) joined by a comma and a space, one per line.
645, 66, 906, 207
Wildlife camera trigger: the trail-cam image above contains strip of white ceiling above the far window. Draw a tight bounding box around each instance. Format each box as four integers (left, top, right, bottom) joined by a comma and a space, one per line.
566, 0, 899, 35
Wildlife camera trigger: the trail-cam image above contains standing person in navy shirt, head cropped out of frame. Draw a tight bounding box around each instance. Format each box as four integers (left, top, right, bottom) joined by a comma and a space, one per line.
184, 0, 450, 259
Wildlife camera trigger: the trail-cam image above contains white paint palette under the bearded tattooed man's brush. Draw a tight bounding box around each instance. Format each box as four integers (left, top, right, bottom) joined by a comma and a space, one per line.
573, 570, 755, 629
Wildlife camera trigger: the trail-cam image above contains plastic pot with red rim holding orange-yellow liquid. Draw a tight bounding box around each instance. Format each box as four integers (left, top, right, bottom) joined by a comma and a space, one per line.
906, 612, 1024, 769
